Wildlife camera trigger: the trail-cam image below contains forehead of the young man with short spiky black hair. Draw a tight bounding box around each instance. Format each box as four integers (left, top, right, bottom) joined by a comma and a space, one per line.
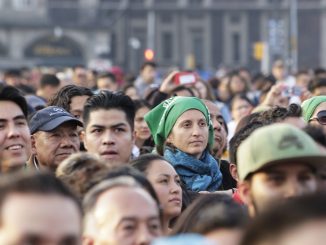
87, 109, 130, 127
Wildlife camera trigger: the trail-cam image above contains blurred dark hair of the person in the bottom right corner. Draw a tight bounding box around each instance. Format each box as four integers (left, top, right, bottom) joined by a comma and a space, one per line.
241, 193, 326, 245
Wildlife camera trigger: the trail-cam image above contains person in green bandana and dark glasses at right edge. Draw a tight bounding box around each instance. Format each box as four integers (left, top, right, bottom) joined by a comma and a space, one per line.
301, 95, 326, 130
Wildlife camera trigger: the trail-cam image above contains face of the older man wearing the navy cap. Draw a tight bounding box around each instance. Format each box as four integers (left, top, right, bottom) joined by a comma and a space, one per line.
32, 122, 80, 171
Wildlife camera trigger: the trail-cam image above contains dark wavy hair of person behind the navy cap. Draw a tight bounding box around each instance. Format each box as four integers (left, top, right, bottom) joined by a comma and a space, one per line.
48, 85, 93, 111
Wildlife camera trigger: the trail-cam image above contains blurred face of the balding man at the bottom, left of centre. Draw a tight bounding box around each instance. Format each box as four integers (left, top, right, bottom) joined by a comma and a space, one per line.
89, 187, 161, 245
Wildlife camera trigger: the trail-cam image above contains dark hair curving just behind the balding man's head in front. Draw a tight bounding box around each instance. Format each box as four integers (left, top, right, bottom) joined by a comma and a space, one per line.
104, 165, 160, 208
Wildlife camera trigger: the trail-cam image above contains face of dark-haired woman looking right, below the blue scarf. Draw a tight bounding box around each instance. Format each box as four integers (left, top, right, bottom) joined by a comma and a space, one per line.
146, 160, 182, 218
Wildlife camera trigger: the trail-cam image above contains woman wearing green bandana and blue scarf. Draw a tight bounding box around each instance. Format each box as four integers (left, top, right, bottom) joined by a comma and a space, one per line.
145, 96, 222, 192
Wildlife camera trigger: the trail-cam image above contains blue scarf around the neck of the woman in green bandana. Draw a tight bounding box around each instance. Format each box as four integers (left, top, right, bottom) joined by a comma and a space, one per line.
164, 148, 222, 192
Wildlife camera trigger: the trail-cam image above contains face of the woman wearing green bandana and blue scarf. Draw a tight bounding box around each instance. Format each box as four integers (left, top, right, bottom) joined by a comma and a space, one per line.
167, 109, 208, 159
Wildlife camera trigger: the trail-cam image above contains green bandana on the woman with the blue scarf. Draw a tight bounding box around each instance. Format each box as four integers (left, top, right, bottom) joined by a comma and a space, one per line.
145, 96, 214, 152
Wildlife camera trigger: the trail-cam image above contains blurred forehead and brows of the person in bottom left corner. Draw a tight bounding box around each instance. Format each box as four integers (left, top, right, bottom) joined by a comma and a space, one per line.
0, 193, 81, 245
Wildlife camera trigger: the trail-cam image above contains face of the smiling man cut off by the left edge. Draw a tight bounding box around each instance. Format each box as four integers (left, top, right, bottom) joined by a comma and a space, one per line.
0, 101, 31, 171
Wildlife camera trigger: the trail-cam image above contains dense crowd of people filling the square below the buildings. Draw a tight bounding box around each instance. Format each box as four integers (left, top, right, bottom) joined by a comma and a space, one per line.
0, 60, 326, 245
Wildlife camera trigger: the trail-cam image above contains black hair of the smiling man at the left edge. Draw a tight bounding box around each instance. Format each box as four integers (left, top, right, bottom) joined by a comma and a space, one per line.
0, 84, 28, 118
